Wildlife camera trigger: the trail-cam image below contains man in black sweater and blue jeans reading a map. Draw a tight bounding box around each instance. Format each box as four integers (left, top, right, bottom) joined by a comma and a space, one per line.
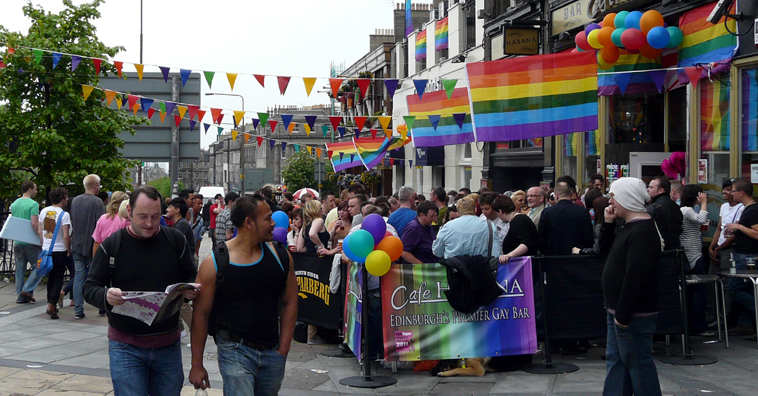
84, 186, 200, 395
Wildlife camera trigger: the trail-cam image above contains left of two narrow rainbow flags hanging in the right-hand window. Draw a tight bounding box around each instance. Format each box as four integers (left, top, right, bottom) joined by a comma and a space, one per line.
698, 79, 729, 151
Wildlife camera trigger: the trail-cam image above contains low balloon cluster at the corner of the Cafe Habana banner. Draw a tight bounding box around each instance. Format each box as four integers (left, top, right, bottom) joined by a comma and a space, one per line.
342, 213, 403, 276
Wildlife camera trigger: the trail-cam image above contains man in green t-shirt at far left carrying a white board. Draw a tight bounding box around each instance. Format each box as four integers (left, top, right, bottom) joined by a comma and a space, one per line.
11, 180, 42, 304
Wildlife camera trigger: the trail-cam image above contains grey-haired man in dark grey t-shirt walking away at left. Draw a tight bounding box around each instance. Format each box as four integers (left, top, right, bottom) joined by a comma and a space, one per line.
70, 174, 105, 319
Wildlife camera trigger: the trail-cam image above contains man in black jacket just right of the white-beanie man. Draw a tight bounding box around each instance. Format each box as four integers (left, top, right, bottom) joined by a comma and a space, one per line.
647, 176, 683, 250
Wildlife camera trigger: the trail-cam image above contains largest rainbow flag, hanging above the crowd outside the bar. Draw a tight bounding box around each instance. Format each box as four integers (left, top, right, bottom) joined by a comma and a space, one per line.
470, 51, 598, 142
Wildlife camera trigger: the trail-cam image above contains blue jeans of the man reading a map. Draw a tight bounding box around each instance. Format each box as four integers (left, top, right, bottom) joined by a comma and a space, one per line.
108, 340, 184, 396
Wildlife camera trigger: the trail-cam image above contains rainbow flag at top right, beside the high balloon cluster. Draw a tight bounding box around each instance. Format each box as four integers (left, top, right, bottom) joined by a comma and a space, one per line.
679, 1, 738, 71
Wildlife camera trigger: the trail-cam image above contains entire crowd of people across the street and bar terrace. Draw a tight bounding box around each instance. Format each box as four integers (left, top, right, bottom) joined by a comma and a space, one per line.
5, 175, 758, 395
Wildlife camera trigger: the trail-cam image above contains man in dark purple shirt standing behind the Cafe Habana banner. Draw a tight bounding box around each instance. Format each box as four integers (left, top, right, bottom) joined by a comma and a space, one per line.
400, 201, 439, 264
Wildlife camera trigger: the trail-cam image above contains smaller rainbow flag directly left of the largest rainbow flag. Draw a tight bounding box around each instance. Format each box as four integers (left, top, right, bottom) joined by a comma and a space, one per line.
406, 88, 475, 147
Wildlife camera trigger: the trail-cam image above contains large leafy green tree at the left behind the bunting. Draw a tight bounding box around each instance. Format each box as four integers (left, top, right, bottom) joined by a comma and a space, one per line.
0, 0, 149, 197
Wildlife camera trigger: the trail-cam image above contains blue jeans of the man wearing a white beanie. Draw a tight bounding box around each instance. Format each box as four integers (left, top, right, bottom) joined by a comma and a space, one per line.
603, 313, 661, 396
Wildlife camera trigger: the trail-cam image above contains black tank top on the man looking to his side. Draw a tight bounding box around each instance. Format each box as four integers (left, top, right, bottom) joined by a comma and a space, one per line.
213, 243, 292, 348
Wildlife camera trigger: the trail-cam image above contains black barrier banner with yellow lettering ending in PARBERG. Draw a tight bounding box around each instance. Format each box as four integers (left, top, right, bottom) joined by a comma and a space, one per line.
292, 253, 340, 330
